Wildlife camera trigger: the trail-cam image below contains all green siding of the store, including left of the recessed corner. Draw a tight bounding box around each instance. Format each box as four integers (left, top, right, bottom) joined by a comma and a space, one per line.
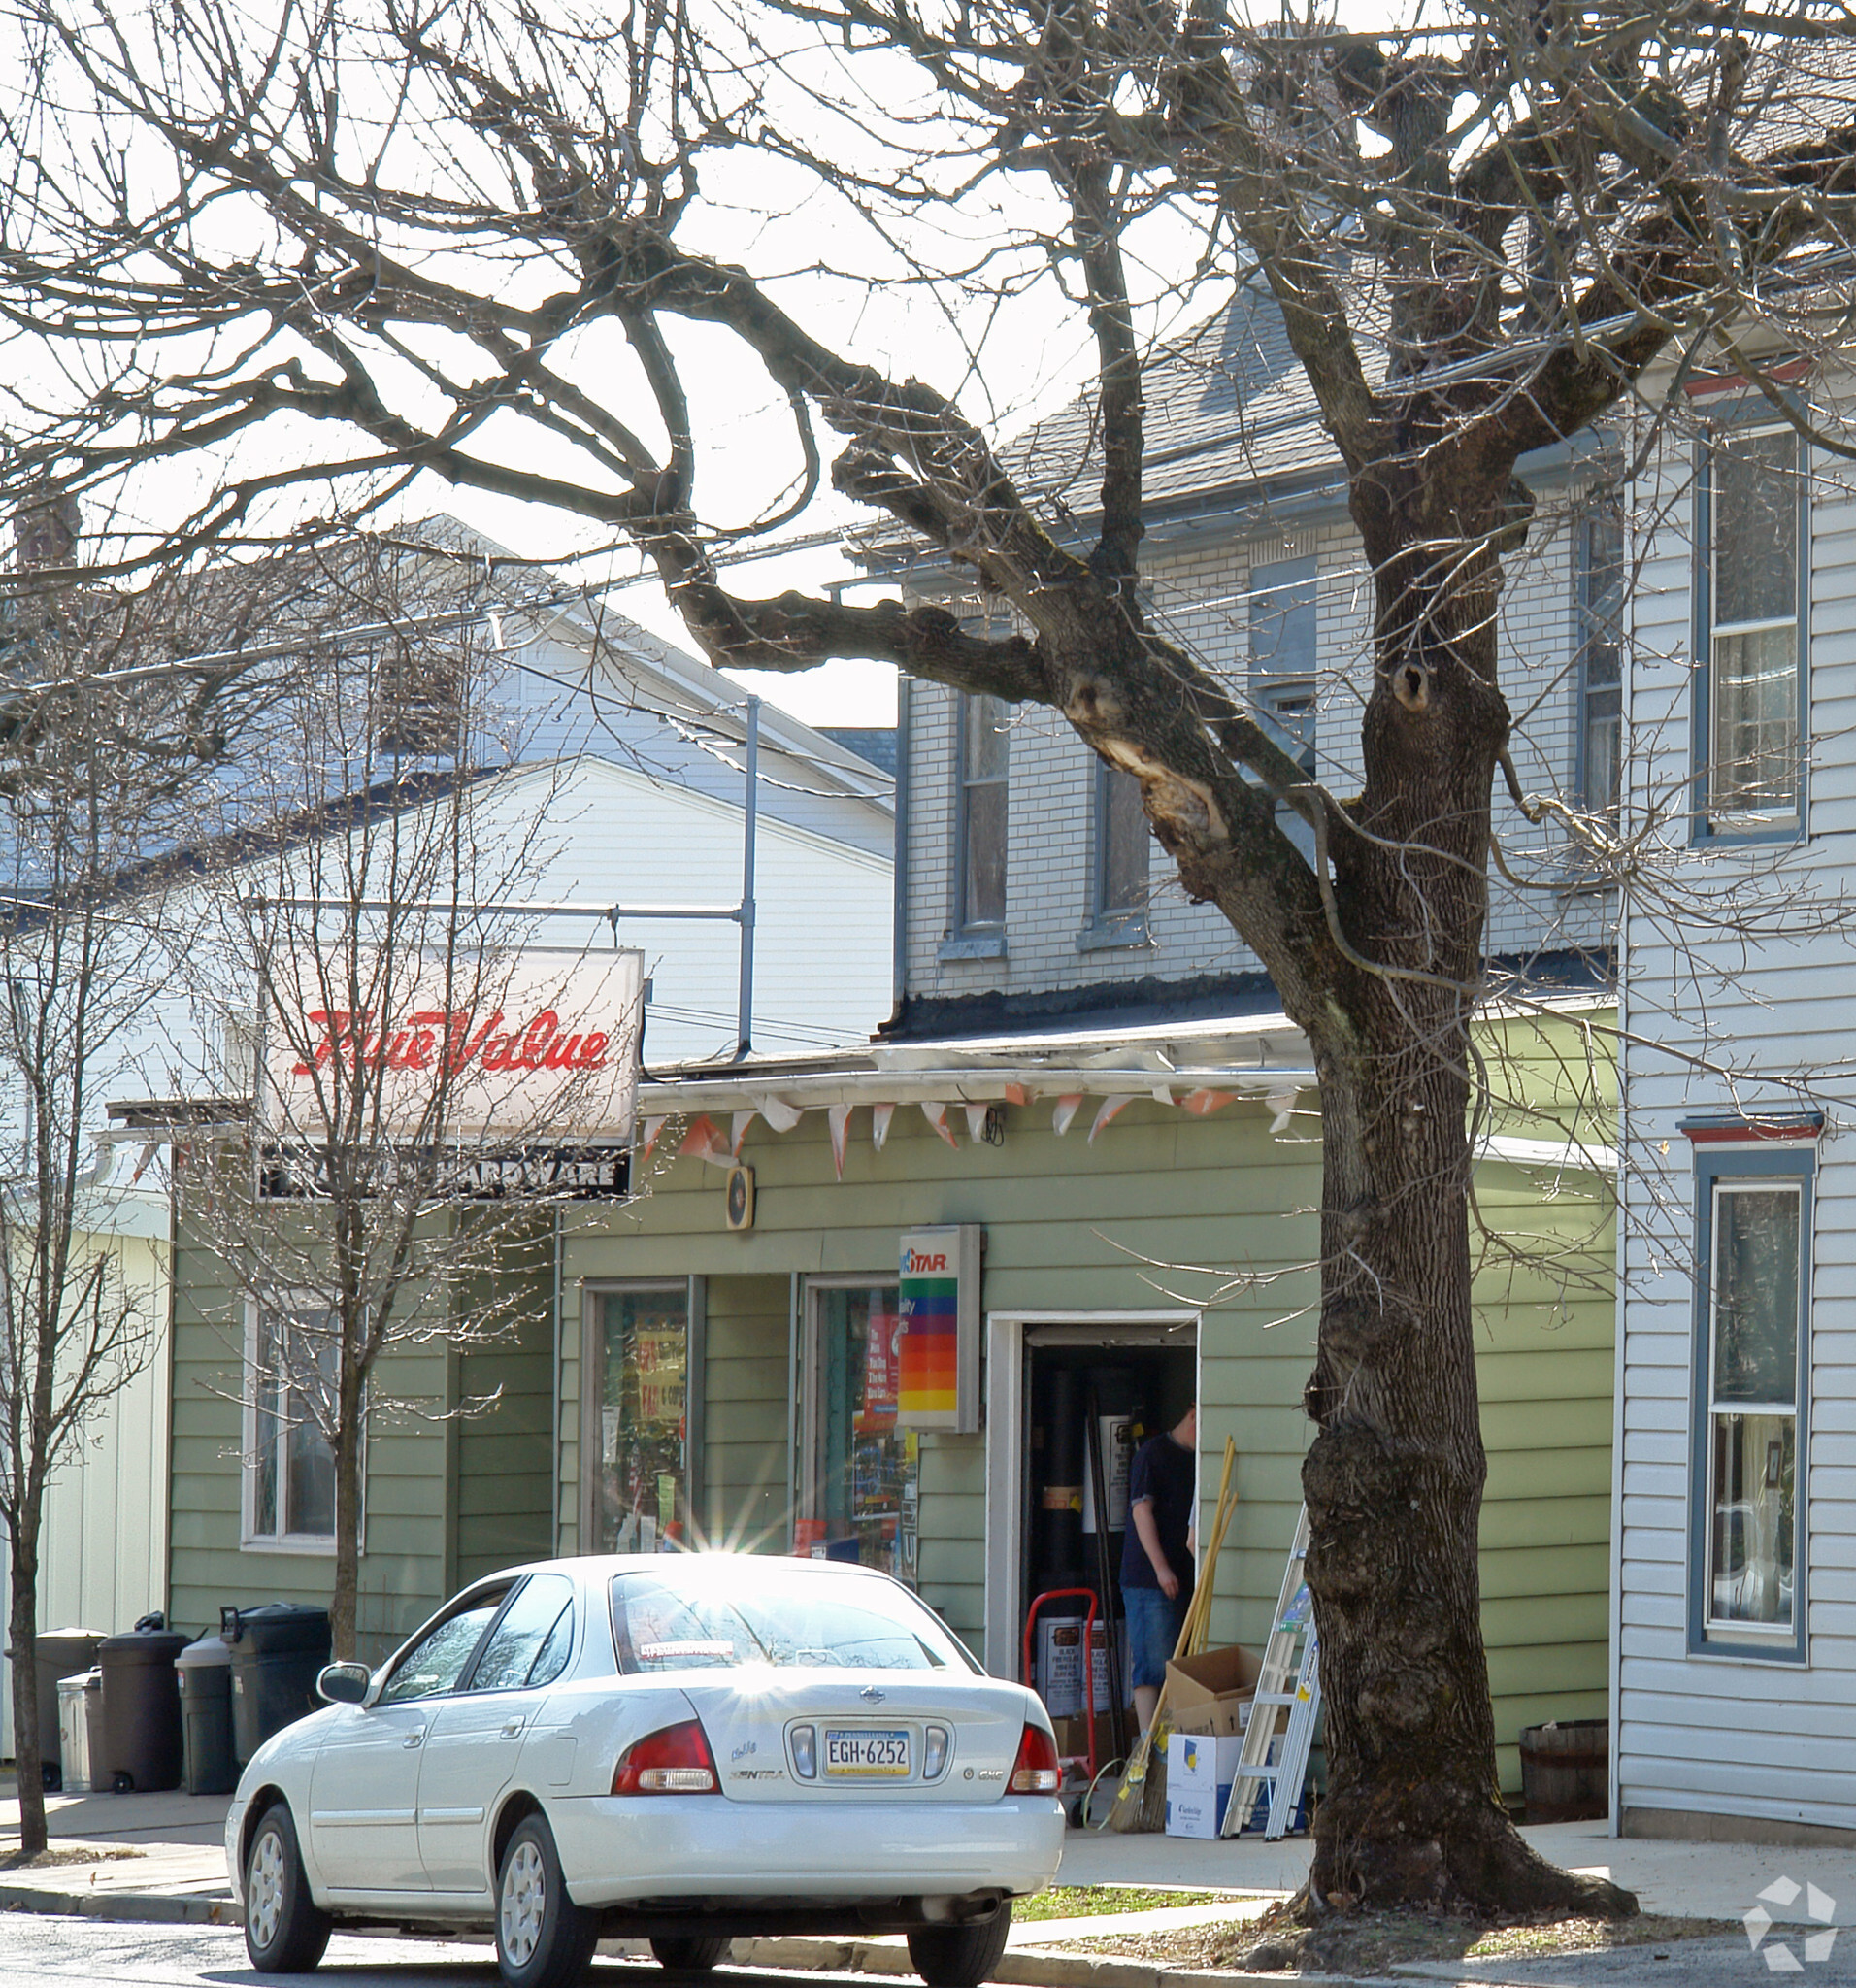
171, 1024, 1613, 1787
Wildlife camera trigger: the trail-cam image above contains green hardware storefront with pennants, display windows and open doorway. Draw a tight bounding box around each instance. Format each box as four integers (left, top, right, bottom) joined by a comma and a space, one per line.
554, 1016, 1611, 1785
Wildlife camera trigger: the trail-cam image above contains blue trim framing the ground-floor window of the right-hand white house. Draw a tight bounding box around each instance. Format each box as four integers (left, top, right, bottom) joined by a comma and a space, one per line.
1687, 1127, 1816, 1664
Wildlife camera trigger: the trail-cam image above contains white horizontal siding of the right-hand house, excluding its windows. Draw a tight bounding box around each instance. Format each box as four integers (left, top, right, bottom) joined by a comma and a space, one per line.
1615, 374, 1856, 1829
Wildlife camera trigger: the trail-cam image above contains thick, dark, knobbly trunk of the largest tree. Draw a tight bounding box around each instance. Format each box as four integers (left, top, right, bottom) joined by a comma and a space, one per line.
1302, 473, 1634, 1912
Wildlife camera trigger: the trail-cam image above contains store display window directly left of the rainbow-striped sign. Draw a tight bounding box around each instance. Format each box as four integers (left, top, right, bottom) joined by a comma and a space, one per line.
793, 1284, 920, 1586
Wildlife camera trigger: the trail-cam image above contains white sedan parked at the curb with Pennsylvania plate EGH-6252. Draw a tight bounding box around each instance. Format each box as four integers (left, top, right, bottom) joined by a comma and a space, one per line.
226, 1552, 1063, 1988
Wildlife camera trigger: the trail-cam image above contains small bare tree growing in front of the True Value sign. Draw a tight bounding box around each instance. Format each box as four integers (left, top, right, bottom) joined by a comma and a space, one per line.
179, 545, 640, 1656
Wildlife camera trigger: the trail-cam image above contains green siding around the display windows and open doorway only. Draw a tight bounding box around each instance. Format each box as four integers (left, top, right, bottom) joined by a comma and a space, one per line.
560, 1030, 1613, 1787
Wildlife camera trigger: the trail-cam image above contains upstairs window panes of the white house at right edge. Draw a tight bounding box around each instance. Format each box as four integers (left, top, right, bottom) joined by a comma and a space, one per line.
1695, 427, 1803, 831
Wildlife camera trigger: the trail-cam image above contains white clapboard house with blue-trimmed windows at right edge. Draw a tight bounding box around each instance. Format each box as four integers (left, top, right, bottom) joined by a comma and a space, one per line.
1611, 338, 1856, 1842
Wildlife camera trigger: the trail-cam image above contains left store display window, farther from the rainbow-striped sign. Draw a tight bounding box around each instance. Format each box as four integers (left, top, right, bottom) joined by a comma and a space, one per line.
588, 1280, 689, 1552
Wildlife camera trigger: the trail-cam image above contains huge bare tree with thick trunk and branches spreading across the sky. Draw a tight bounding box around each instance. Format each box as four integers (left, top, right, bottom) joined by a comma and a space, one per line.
0, 0, 1856, 1908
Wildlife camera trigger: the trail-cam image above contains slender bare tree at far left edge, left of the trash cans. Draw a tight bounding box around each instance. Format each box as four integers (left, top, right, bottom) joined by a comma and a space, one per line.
0, 491, 268, 1853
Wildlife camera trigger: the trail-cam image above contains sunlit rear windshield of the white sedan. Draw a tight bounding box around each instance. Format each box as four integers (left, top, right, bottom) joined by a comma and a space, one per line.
613, 1555, 978, 1672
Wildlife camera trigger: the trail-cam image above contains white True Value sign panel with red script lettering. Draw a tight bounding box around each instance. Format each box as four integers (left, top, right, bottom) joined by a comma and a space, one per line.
260, 946, 644, 1149
